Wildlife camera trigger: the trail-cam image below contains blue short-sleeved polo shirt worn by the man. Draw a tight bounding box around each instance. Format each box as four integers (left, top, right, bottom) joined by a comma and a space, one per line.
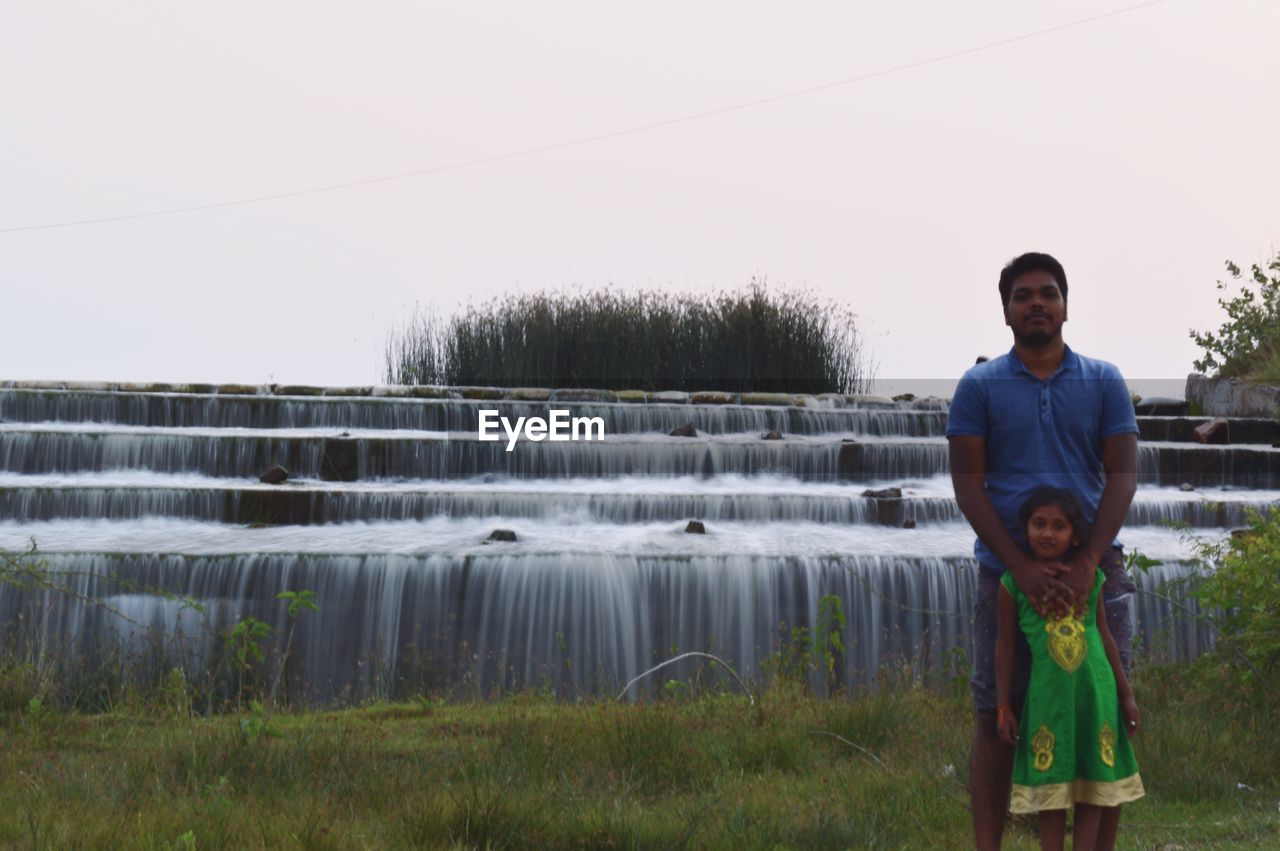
947, 347, 1138, 573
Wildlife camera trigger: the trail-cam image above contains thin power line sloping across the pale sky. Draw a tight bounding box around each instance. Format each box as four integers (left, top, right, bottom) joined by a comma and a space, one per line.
0, 0, 1169, 234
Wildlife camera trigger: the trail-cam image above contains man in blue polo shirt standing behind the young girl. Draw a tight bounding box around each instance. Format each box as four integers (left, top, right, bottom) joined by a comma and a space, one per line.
947, 253, 1138, 850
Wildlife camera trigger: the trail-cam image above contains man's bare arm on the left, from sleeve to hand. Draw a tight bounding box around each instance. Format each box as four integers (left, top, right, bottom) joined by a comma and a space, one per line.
947, 435, 1070, 616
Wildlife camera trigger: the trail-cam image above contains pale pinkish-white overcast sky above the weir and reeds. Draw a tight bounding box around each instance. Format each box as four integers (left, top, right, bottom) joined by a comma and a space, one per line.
0, 0, 1280, 384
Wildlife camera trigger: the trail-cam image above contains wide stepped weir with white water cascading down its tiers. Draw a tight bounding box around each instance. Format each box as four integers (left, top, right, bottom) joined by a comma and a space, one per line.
0, 383, 1280, 703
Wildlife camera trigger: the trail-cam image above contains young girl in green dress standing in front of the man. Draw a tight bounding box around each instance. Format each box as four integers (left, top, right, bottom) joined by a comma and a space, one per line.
996, 488, 1143, 851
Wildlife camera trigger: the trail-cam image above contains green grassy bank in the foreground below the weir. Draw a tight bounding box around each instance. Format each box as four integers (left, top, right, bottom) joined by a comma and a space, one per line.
0, 663, 1280, 848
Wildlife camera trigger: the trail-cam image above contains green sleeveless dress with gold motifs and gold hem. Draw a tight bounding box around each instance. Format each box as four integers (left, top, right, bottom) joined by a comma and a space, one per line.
1001, 571, 1143, 813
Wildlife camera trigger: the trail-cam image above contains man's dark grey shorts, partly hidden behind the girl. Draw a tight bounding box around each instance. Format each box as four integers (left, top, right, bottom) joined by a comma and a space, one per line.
969, 546, 1137, 712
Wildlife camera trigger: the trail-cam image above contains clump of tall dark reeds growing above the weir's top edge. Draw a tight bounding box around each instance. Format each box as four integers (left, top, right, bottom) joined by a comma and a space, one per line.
385, 280, 872, 393
